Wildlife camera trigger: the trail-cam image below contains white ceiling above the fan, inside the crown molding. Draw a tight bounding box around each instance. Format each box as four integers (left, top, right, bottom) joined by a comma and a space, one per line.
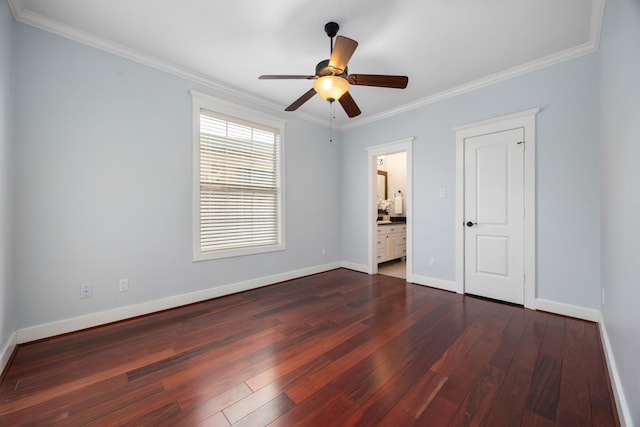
9, 0, 605, 128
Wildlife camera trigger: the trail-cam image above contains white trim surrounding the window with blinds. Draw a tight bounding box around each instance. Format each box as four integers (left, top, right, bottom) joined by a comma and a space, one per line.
189, 90, 287, 262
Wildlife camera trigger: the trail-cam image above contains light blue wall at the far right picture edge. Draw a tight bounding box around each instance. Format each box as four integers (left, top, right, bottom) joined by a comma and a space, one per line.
600, 0, 640, 425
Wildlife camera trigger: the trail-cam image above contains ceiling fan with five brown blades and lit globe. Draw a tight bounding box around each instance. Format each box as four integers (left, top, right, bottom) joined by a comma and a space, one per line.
258, 22, 409, 117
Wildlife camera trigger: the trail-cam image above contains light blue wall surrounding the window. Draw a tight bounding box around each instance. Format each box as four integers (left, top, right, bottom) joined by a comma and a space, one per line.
16, 24, 340, 329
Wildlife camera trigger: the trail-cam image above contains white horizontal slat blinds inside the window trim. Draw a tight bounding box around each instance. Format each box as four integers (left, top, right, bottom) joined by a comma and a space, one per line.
199, 109, 281, 256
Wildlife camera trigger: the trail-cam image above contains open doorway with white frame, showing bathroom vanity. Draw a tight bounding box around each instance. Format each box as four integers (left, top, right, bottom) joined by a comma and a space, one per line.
368, 138, 413, 282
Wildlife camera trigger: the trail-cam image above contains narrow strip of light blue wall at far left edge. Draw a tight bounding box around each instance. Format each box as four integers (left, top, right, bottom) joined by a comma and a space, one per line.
0, 2, 15, 360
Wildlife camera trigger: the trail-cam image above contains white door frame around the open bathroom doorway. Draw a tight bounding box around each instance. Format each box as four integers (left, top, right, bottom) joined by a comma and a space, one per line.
367, 137, 415, 282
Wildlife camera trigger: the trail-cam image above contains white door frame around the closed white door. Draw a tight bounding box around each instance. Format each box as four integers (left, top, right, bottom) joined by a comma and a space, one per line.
453, 108, 540, 308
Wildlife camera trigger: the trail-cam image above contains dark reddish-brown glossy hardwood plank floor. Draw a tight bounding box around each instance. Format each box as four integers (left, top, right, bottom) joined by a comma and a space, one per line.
0, 269, 619, 426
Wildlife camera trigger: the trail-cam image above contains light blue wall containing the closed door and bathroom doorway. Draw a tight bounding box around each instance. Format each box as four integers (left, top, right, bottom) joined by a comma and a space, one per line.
341, 54, 600, 308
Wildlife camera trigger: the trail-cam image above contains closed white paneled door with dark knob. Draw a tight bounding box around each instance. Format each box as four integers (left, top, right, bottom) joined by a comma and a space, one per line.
464, 128, 525, 304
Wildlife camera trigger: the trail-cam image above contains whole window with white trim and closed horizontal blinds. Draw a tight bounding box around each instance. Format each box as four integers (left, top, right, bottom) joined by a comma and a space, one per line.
191, 91, 284, 261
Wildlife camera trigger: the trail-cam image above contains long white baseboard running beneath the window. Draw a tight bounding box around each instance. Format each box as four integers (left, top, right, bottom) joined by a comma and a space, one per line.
14, 262, 342, 344
